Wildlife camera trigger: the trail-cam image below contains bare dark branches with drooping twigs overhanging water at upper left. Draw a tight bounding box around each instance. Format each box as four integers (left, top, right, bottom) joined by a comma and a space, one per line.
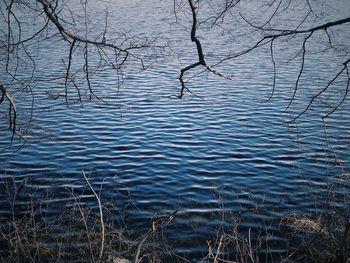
0, 0, 163, 142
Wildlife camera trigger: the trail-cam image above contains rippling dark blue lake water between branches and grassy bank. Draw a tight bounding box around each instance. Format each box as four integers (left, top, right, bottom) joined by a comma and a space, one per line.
0, 1, 350, 259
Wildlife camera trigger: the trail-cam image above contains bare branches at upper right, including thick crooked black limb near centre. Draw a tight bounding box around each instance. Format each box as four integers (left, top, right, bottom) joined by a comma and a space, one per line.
174, 0, 350, 121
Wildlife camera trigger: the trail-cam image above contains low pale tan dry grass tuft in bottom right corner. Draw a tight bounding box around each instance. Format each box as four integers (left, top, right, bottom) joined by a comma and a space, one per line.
283, 214, 350, 263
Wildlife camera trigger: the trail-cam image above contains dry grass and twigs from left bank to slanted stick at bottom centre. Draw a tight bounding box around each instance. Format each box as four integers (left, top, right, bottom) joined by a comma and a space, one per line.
0, 173, 185, 263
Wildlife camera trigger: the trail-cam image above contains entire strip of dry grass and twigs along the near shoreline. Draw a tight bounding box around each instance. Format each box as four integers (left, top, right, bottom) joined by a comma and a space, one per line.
0, 171, 350, 263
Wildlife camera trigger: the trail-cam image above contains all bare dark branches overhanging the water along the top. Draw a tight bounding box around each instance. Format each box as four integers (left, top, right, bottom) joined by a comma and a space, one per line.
0, 0, 350, 142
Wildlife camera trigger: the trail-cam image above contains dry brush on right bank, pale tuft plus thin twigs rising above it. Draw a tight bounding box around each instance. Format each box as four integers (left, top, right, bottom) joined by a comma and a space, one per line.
281, 173, 350, 263
